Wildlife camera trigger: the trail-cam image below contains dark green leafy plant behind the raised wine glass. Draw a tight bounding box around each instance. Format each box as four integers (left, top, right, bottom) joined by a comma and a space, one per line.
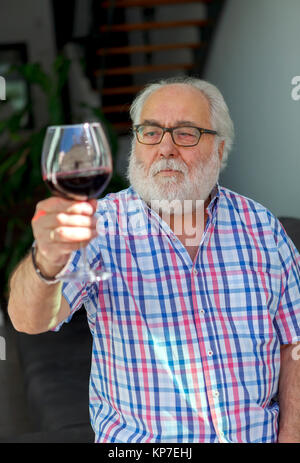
0, 56, 126, 304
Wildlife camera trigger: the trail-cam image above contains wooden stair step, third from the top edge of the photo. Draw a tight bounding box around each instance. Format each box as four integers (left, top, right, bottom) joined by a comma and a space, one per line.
97, 42, 207, 56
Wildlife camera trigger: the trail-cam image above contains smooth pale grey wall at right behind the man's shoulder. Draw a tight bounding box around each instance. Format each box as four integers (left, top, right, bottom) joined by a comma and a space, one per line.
204, 0, 300, 217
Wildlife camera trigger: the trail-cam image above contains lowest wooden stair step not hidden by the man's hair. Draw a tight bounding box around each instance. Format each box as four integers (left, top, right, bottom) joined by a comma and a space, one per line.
94, 63, 197, 76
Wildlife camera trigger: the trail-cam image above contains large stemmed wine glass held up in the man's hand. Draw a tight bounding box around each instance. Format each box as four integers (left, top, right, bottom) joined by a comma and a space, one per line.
42, 122, 112, 282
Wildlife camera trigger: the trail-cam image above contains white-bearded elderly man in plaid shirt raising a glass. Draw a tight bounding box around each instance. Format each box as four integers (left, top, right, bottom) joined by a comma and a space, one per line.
8, 78, 300, 443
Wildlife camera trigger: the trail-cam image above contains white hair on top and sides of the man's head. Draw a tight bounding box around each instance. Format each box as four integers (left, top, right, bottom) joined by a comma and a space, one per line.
130, 77, 234, 170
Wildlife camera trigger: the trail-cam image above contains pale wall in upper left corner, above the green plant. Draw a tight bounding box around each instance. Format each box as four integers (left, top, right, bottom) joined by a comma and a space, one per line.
0, 0, 56, 126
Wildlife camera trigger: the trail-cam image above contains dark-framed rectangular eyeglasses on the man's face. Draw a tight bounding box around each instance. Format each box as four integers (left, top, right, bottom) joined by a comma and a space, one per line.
133, 124, 218, 146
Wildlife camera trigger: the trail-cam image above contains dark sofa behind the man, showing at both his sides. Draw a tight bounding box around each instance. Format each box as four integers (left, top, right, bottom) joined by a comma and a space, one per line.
5, 217, 300, 443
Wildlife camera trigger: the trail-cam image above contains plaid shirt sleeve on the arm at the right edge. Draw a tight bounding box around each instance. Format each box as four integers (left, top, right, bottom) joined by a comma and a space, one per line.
274, 222, 300, 344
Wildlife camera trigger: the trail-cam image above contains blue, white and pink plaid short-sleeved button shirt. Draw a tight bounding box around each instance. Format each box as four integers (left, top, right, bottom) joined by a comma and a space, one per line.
56, 186, 300, 443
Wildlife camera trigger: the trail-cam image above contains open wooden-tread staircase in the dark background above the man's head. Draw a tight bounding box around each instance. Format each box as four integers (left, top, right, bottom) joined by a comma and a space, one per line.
88, 0, 225, 134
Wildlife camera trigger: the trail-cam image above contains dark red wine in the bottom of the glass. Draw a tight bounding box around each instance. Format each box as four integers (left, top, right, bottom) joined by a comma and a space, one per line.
45, 169, 111, 199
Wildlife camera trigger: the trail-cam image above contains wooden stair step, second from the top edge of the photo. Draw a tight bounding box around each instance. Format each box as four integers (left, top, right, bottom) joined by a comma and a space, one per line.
99, 19, 214, 32
